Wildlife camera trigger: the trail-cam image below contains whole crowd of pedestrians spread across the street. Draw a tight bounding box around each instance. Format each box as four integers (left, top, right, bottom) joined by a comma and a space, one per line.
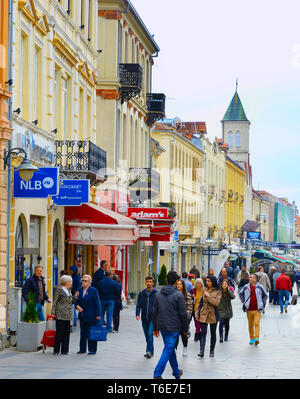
22, 261, 300, 370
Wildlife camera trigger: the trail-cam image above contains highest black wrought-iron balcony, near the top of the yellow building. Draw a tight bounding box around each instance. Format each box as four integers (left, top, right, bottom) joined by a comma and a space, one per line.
120, 64, 143, 104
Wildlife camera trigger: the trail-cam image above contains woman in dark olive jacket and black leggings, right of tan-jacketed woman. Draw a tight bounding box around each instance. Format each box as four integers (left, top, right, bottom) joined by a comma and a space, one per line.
218, 280, 235, 343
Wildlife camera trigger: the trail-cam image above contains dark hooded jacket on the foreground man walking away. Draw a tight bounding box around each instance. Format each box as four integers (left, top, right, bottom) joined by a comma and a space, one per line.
152, 285, 190, 333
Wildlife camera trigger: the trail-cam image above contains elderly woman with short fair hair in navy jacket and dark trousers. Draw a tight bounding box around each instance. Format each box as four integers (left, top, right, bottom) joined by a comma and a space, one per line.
75, 274, 101, 355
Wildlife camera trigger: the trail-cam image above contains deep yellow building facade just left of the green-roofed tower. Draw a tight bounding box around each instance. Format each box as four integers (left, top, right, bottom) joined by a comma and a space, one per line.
224, 156, 246, 244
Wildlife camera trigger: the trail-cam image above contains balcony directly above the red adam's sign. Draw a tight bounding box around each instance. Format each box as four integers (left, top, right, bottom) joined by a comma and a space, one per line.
129, 168, 160, 204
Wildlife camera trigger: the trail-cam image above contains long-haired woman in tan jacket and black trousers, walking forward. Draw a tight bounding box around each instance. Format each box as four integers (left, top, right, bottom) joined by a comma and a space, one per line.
196, 276, 221, 358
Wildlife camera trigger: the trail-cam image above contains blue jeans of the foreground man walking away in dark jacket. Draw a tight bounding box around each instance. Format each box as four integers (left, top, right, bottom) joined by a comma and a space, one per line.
153, 331, 180, 378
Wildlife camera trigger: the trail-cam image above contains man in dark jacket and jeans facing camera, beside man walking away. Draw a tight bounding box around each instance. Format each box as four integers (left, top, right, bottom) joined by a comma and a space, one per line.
135, 276, 158, 359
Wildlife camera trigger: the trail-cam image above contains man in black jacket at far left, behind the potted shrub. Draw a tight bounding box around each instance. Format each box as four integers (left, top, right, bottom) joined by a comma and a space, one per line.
22, 265, 51, 321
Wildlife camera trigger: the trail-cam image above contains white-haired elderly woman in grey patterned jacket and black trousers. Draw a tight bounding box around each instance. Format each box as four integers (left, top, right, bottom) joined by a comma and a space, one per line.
51, 275, 78, 355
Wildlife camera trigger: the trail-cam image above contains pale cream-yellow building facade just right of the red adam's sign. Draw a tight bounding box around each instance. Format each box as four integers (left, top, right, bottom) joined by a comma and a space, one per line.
152, 123, 204, 273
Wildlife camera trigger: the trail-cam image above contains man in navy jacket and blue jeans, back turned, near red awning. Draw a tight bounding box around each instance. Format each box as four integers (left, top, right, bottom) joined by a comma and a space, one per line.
96, 271, 122, 333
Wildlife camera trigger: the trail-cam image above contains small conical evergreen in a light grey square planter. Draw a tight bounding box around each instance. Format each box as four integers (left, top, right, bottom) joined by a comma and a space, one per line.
17, 291, 46, 352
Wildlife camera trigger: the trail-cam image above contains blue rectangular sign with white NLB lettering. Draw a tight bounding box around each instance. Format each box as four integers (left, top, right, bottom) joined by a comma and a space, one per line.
13, 168, 59, 198
